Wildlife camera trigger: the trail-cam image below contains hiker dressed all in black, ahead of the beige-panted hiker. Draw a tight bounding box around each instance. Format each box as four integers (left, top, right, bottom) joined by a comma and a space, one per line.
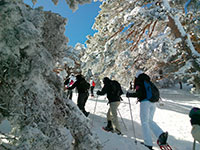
68, 75, 90, 117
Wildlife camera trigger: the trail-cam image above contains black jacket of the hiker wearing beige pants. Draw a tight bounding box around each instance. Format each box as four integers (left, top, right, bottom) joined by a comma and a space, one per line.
97, 78, 121, 103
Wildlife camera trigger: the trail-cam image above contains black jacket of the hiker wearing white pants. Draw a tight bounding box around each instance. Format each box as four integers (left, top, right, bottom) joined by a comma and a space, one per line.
128, 73, 150, 102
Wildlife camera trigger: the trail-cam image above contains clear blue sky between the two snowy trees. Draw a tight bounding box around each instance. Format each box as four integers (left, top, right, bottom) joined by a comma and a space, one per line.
24, 0, 101, 47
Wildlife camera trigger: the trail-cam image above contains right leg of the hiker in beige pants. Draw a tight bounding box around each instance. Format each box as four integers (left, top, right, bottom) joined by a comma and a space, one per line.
110, 101, 121, 132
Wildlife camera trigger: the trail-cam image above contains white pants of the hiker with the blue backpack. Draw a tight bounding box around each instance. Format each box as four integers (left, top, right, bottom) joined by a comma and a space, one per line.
140, 100, 163, 146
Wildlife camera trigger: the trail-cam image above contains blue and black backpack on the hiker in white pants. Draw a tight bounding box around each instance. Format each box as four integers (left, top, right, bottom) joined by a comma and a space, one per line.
144, 81, 160, 103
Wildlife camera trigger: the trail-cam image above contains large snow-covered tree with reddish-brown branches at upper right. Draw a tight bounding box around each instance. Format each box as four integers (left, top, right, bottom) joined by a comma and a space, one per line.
83, 0, 200, 91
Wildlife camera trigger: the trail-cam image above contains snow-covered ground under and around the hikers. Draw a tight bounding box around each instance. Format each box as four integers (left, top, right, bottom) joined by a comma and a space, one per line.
73, 87, 200, 150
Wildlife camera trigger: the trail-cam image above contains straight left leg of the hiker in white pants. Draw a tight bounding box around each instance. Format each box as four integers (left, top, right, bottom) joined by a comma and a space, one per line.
140, 101, 153, 146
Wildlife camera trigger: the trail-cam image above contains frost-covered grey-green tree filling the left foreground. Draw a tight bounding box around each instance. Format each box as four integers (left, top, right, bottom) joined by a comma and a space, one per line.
0, 0, 101, 150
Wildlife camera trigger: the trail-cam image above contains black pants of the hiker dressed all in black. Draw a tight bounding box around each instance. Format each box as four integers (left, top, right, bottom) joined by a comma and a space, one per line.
77, 92, 89, 114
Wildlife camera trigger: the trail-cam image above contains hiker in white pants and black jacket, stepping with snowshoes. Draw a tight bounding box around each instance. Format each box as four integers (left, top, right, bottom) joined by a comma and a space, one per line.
126, 70, 168, 150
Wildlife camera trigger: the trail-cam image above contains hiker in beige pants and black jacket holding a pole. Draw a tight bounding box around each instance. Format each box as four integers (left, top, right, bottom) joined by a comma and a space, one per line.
97, 77, 121, 134
